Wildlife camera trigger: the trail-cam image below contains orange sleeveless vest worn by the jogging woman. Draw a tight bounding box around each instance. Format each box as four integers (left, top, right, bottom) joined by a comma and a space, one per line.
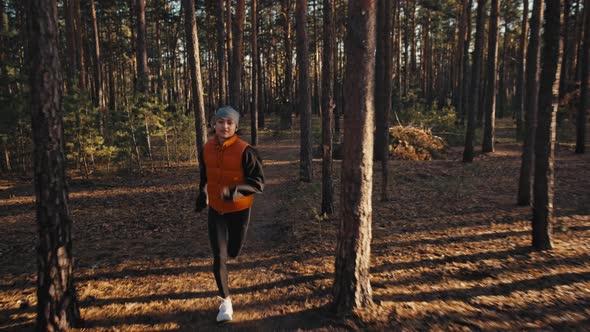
203, 135, 254, 214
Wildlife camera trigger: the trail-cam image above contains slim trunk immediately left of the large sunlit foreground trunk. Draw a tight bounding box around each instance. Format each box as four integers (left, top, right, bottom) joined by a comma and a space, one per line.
322, 0, 336, 214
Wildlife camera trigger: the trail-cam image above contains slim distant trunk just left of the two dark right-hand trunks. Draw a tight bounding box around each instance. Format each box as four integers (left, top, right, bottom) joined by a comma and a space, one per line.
513, 0, 529, 140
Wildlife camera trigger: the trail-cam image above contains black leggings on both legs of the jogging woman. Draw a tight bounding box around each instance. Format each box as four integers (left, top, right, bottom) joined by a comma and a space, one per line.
208, 208, 250, 298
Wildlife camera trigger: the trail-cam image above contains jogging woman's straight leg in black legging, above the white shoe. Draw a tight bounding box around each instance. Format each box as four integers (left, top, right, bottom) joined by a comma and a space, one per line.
208, 208, 229, 298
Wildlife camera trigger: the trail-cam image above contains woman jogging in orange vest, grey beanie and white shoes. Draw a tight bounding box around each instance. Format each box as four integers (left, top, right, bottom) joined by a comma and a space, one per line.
195, 106, 264, 322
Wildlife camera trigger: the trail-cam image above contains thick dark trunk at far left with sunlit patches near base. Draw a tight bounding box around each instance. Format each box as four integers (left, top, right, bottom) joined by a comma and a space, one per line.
27, 0, 80, 331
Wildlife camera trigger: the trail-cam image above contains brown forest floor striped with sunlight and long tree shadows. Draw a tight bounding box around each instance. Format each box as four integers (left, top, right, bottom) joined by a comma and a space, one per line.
0, 118, 590, 331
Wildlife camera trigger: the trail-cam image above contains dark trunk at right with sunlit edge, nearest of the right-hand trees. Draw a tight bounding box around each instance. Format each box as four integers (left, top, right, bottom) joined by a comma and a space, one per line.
533, 0, 563, 250
